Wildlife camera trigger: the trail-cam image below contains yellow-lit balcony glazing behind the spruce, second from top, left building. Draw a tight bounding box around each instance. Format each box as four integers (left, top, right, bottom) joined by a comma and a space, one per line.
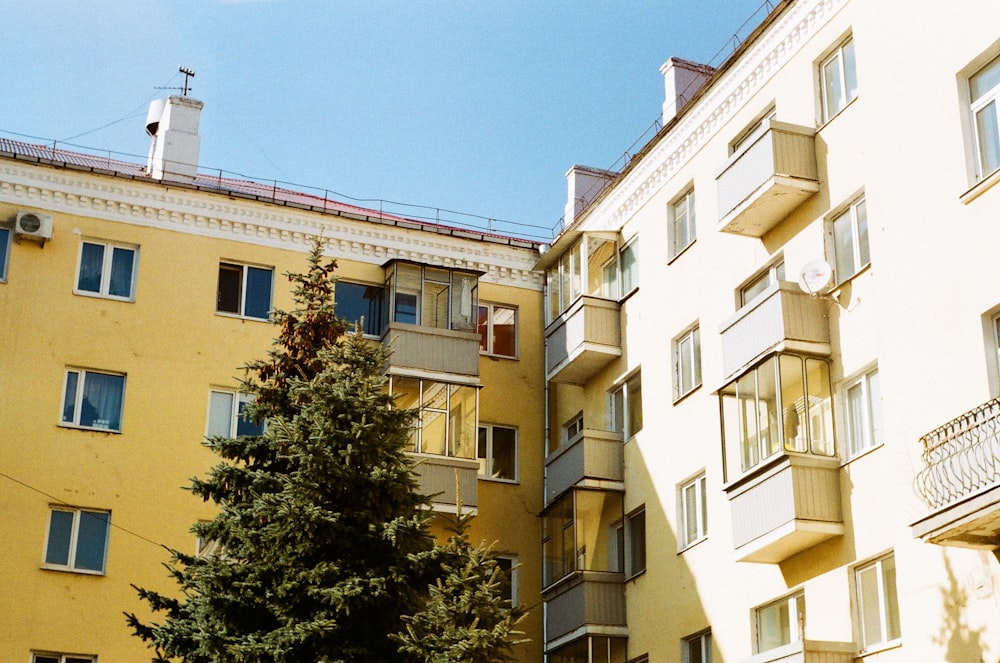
389, 375, 478, 458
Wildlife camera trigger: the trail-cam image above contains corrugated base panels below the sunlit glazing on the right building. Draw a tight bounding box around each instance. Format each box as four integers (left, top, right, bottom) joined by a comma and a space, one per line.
725, 453, 844, 564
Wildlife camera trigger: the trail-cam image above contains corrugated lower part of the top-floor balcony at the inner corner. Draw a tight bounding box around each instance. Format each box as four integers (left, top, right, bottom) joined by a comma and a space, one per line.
545, 295, 622, 384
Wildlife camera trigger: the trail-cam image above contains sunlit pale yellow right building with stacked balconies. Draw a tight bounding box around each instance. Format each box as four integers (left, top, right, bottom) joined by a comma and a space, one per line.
539, 0, 1000, 663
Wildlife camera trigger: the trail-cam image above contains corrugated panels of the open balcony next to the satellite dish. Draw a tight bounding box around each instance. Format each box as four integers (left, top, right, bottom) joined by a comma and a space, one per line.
719, 281, 830, 378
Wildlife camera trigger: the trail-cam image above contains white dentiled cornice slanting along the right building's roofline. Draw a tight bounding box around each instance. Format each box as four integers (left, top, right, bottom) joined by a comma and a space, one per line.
579, 0, 849, 231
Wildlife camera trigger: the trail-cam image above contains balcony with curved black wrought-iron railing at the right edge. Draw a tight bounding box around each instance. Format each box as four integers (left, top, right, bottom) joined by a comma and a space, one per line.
912, 399, 1000, 550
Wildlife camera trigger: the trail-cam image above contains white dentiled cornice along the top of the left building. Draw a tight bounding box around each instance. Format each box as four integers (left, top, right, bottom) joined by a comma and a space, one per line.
0, 159, 543, 290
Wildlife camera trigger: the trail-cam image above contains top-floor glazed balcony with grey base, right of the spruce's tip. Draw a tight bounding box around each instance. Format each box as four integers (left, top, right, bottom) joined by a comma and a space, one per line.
382, 260, 480, 376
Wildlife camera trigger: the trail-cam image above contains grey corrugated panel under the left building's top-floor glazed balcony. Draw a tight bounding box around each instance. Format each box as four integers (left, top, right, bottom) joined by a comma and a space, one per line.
382, 322, 479, 377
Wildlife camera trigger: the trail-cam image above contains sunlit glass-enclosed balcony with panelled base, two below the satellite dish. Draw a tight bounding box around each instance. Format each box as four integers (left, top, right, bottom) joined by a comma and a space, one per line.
719, 353, 844, 563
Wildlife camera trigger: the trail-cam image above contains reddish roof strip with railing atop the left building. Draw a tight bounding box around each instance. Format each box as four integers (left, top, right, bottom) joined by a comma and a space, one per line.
0, 137, 542, 249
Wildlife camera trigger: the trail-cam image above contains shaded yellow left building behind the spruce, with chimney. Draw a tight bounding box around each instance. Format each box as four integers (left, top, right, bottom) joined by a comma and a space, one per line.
0, 91, 544, 663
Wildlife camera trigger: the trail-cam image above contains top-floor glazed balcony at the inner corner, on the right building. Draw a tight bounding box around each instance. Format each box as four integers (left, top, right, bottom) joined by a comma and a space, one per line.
543, 232, 638, 384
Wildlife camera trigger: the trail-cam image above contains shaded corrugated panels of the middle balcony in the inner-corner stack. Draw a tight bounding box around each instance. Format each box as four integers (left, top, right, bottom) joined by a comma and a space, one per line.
545, 428, 625, 506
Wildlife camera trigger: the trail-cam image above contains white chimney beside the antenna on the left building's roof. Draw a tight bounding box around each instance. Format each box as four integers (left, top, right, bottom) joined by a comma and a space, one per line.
146, 95, 204, 183
